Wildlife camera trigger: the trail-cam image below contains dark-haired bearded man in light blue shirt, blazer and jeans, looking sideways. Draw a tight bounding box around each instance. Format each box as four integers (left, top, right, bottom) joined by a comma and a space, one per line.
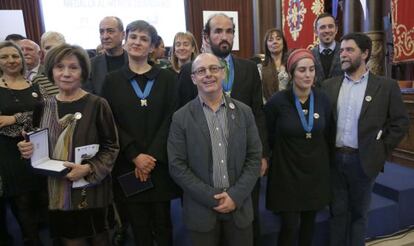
323, 33, 409, 246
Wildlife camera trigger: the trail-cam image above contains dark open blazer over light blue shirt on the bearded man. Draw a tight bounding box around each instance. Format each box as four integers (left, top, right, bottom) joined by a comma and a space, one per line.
322, 73, 409, 177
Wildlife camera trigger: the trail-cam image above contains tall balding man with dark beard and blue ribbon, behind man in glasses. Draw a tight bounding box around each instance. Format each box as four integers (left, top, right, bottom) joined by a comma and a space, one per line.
179, 14, 269, 245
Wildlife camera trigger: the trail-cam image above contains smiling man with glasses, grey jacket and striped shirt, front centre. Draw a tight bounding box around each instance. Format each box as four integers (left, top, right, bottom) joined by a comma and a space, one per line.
167, 53, 262, 246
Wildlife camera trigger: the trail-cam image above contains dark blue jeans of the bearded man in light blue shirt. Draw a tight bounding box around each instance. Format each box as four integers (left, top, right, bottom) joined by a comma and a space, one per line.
330, 152, 375, 246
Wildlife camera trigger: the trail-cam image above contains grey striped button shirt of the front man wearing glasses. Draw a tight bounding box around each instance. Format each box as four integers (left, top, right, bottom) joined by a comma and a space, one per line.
200, 98, 230, 190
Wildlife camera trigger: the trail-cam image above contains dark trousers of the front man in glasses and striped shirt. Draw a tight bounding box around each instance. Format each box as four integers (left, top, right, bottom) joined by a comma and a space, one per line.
189, 218, 253, 246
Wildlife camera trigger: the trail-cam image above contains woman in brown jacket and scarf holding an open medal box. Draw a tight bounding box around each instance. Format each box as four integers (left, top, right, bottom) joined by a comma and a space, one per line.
18, 44, 119, 245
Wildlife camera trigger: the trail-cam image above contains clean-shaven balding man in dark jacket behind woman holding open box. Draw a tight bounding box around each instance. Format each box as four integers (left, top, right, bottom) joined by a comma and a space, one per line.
89, 16, 128, 95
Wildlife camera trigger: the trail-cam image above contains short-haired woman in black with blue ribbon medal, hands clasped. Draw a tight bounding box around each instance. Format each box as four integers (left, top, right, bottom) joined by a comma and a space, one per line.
102, 20, 178, 246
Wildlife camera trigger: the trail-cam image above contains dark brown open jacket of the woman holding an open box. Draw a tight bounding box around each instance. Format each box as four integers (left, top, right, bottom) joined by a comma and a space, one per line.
40, 94, 119, 210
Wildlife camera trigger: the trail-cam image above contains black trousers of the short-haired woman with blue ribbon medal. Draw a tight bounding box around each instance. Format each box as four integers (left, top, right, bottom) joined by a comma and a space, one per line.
126, 201, 173, 246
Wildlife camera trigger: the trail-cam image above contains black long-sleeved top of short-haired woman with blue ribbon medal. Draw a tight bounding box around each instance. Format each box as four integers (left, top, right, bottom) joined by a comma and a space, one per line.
102, 65, 179, 202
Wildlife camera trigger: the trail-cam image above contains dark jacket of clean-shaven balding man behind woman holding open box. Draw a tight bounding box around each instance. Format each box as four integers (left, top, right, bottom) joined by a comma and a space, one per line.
89, 51, 128, 95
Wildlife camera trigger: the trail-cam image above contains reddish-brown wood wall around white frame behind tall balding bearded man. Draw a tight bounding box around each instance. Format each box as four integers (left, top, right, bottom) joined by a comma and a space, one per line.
185, 0, 254, 58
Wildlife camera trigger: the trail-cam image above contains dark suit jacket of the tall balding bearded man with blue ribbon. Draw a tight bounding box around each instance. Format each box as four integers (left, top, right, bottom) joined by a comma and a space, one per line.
178, 56, 269, 157
